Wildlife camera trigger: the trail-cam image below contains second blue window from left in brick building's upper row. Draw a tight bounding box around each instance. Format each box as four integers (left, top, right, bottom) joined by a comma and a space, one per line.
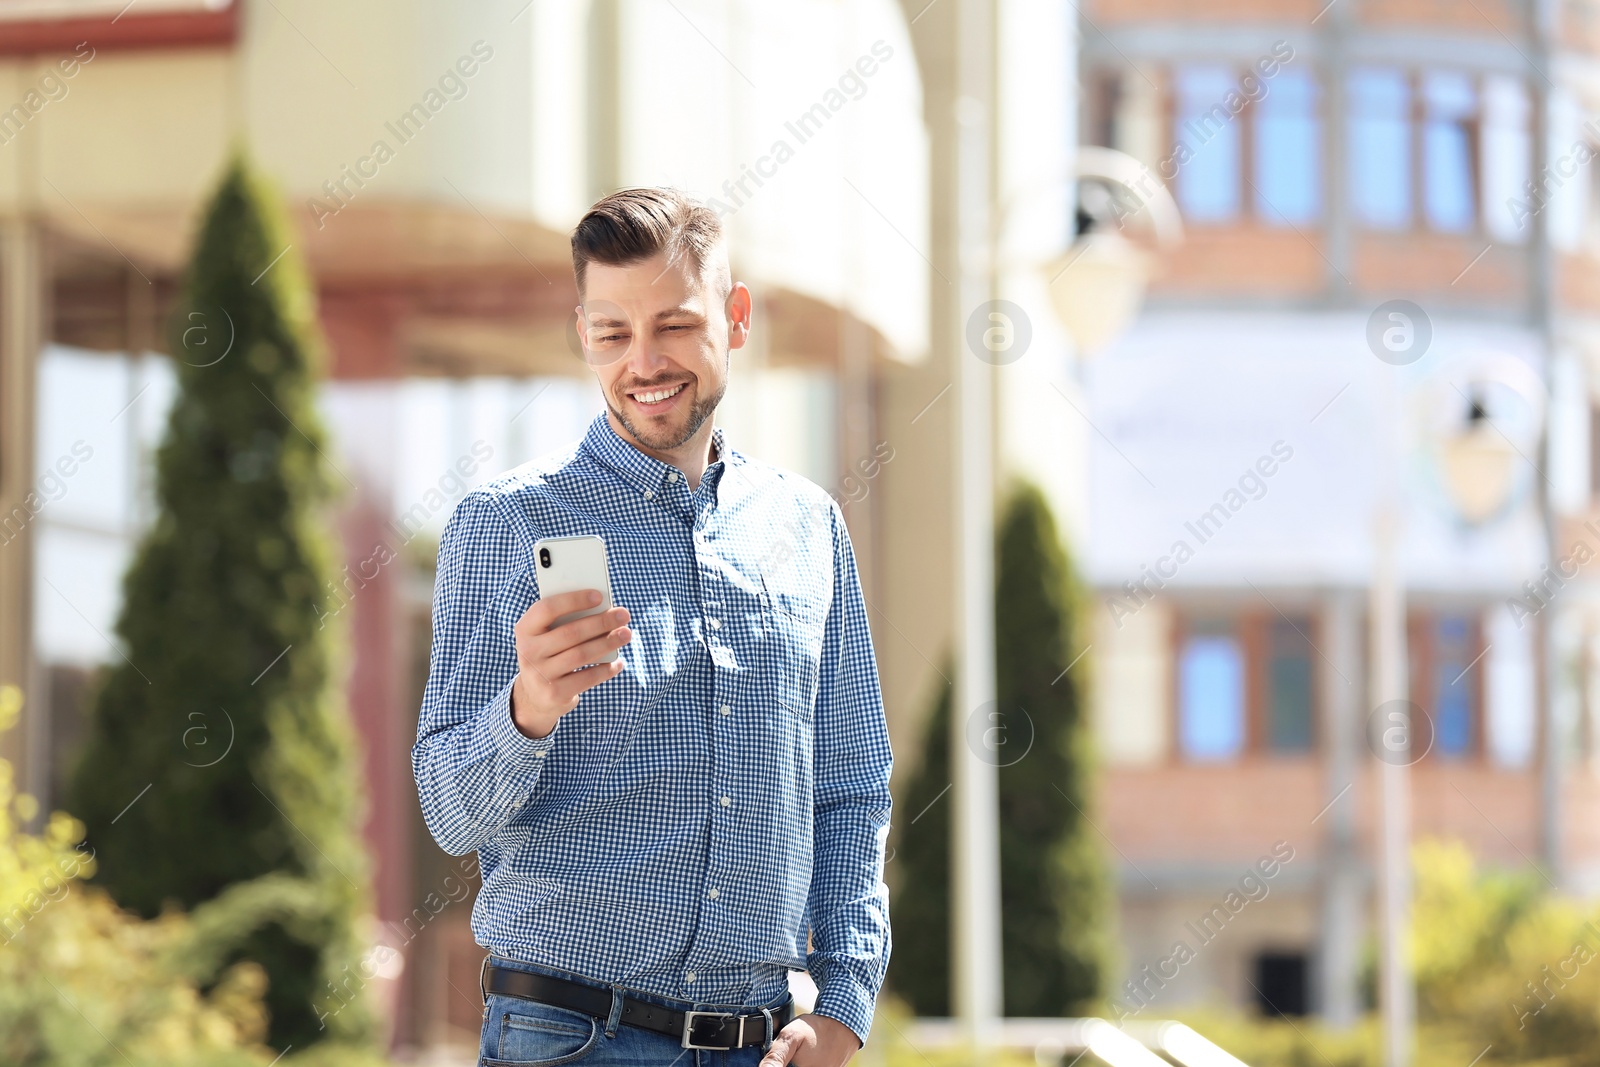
1254, 70, 1322, 226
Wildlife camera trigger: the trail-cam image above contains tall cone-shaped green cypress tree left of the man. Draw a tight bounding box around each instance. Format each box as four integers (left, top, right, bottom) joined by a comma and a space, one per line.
70, 157, 371, 1049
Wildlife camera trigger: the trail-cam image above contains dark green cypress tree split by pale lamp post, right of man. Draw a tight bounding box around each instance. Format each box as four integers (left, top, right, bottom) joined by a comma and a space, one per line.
888, 486, 1110, 1016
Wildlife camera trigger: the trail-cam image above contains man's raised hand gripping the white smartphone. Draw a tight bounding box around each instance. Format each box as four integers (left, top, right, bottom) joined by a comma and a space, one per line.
510, 589, 634, 737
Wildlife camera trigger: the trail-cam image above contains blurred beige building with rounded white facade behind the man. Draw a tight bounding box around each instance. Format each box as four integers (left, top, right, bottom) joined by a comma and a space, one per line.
0, 0, 928, 1046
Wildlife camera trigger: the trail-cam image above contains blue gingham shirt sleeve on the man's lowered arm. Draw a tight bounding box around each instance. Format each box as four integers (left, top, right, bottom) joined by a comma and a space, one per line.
806, 507, 893, 1045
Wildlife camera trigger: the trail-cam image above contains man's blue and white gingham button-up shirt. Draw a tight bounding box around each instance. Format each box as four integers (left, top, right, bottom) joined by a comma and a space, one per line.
411, 414, 891, 1043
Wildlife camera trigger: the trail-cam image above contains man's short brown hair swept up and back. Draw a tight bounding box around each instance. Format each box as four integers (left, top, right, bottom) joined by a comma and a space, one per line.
573, 189, 731, 298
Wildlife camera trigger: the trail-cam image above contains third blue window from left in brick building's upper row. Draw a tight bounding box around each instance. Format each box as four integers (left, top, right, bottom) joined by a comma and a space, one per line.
1347, 67, 1411, 230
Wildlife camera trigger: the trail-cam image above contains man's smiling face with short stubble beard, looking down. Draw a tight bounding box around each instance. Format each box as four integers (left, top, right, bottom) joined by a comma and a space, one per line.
578, 253, 750, 451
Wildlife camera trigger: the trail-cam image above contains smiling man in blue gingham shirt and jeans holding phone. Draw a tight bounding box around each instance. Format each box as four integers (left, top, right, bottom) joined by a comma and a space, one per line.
413, 189, 891, 1067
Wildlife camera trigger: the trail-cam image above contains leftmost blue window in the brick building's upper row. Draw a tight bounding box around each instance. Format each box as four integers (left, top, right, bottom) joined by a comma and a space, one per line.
1173, 67, 1242, 222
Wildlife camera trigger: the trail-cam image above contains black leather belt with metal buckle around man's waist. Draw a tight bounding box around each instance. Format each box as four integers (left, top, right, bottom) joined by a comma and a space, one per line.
483, 961, 795, 1049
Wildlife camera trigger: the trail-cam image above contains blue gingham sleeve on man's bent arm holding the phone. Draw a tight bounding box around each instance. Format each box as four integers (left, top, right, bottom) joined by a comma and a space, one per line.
411, 493, 560, 856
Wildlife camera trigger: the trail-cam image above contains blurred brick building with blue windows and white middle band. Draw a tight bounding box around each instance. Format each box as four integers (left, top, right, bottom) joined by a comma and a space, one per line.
1080, 0, 1600, 1021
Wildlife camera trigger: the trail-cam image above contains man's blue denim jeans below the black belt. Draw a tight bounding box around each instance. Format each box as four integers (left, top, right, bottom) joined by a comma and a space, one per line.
478, 955, 787, 1067
